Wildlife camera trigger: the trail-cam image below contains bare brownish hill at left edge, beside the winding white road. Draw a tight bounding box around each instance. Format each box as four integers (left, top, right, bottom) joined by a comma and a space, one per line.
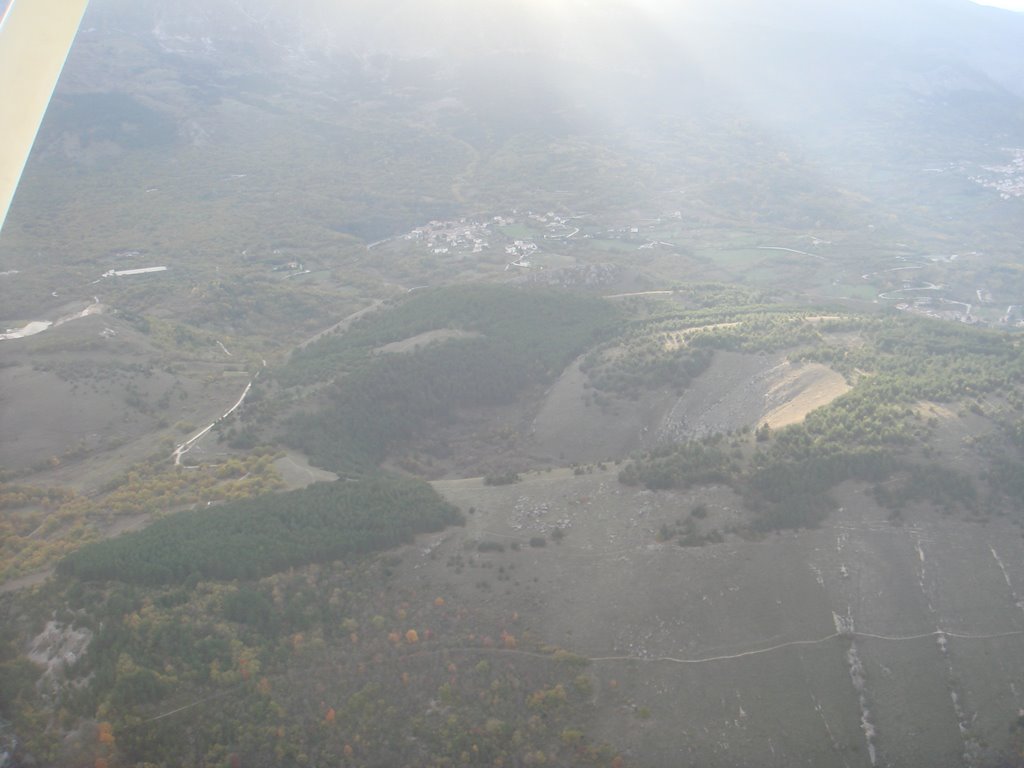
0, 314, 248, 485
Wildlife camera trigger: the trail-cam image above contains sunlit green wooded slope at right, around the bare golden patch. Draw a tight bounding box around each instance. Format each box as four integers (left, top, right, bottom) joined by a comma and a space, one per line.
620, 311, 1024, 529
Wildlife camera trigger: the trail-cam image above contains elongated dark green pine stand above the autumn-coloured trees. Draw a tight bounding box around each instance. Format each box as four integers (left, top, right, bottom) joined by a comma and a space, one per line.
58, 476, 462, 585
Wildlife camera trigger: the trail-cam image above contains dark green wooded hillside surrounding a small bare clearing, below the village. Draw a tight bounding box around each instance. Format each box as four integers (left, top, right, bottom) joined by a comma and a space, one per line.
279, 286, 616, 473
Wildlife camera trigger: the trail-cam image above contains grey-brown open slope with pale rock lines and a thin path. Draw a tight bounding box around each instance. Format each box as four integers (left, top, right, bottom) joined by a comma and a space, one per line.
387, 470, 1024, 767
